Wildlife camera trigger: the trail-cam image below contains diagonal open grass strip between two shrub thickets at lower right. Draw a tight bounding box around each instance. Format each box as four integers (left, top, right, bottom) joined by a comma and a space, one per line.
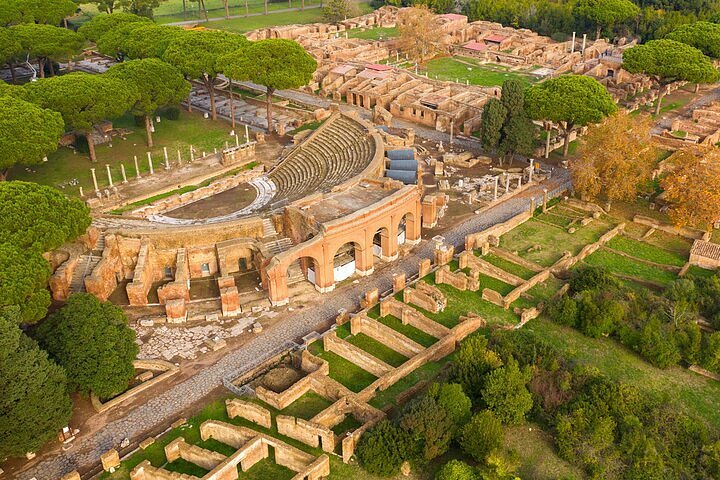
523, 317, 720, 428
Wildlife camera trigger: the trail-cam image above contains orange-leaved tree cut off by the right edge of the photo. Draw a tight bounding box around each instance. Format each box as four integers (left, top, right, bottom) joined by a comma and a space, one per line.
660, 146, 720, 231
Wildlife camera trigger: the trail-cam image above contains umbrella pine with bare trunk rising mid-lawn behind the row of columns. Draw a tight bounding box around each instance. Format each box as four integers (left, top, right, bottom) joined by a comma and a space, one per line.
107, 58, 191, 147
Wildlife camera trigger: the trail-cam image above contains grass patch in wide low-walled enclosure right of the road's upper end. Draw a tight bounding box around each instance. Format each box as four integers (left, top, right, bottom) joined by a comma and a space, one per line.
500, 214, 612, 267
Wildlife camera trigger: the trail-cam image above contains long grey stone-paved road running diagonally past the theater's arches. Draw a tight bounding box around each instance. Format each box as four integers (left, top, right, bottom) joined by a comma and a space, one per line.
17, 163, 569, 480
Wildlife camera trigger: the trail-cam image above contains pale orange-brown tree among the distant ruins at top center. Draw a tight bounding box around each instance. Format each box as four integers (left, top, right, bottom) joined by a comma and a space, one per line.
397, 5, 443, 63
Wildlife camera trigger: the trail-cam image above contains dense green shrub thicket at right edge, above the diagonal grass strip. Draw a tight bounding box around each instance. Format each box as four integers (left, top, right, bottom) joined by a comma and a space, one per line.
548, 267, 720, 373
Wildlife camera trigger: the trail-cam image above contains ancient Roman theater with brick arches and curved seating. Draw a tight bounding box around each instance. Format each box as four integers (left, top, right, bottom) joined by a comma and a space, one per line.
51, 108, 437, 322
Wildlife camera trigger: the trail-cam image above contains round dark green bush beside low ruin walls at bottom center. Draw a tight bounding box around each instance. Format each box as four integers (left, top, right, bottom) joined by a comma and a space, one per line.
356, 420, 412, 477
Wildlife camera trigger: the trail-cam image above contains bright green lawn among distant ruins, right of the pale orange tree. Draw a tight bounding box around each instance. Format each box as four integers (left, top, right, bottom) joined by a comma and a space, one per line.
423, 57, 537, 87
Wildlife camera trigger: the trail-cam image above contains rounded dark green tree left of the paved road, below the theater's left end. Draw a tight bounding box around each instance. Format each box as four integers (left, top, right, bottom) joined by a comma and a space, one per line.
37, 293, 139, 398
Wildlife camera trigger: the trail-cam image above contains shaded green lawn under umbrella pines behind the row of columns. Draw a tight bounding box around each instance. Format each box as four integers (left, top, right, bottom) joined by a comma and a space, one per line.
10, 111, 238, 196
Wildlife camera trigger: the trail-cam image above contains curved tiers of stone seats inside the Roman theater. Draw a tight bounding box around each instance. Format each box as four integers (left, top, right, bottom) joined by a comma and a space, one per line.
268, 114, 376, 202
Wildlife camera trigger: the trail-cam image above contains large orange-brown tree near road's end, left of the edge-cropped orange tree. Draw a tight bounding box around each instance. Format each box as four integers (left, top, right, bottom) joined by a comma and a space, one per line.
570, 113, 657, 208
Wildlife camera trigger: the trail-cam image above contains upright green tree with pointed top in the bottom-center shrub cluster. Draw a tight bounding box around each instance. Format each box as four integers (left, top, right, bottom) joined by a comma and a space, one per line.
482, 358, 533, 425
